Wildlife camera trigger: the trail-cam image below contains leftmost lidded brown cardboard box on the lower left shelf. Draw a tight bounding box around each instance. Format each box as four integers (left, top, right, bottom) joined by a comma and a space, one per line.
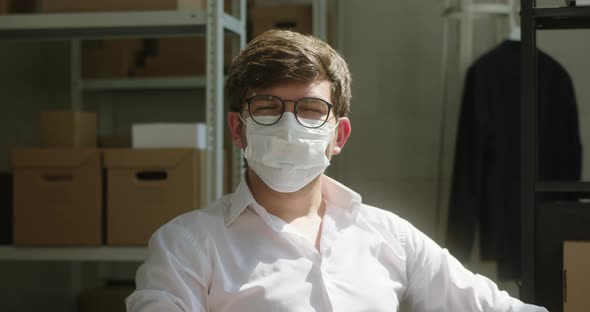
11, 149, 103, 246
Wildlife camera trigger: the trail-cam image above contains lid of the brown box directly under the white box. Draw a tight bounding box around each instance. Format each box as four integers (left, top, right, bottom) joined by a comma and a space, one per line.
104, 148, 198, 169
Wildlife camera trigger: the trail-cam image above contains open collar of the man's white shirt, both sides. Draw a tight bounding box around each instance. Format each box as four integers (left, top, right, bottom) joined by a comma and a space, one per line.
224, 175, 362, 227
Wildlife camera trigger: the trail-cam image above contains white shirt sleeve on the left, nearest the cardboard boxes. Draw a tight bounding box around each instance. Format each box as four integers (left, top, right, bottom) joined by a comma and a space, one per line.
125, 223, 211, 312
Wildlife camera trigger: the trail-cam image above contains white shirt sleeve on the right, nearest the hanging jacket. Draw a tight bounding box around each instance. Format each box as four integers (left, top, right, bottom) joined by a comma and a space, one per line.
402, 222, 547, 312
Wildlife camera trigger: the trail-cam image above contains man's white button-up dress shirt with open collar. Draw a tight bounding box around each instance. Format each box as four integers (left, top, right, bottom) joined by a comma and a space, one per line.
126, 176, 547, 312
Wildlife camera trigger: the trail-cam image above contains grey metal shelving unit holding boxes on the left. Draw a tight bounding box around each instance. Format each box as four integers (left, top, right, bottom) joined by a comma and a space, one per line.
0, 0, 246, 261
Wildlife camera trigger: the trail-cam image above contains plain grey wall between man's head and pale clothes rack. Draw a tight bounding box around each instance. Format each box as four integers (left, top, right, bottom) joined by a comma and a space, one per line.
337, 1, 442, 240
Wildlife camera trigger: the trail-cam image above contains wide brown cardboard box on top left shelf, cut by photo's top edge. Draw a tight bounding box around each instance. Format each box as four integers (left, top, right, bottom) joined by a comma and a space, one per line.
41, 0, 207, 12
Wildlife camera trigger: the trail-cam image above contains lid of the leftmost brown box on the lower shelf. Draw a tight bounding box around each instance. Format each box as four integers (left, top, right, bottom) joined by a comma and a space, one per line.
11, 148, 100, 168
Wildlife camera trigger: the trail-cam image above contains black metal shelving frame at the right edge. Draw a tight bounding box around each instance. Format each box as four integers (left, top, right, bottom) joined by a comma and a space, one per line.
520, 0, 590, 302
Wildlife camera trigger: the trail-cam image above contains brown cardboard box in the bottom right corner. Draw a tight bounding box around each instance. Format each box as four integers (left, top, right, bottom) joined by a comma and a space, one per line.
563, 241, 590, 312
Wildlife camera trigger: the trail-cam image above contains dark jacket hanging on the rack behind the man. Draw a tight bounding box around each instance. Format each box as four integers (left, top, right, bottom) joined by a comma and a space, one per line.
447, 41, 581, 279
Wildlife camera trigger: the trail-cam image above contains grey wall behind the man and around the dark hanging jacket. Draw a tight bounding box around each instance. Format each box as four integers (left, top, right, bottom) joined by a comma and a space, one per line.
332, 0, 590, 296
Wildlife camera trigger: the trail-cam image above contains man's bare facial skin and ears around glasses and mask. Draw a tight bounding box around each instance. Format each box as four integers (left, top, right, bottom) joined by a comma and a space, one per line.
228, 80, 351, 158
